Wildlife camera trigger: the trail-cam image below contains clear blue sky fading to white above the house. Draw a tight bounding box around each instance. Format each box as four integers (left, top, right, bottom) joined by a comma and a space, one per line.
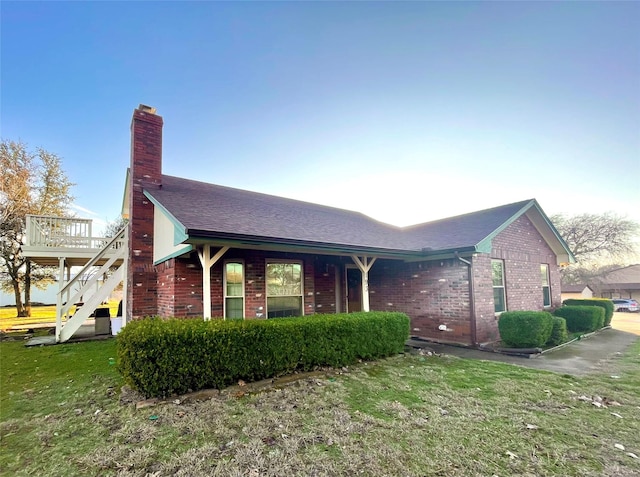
0, 1, 640, 232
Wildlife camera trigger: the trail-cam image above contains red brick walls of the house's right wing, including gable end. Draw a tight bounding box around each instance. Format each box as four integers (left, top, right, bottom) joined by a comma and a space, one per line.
362, 216, 561, 345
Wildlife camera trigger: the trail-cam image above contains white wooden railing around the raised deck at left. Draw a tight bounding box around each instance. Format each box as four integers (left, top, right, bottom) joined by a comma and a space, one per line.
25, 215, 123, 249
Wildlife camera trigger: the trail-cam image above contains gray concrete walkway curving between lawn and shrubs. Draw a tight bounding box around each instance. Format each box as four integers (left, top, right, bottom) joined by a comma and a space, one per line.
410, 328, 640, 376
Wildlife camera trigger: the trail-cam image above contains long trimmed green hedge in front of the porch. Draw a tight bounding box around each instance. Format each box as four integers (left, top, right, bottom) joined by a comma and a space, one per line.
117, 312, 409, 397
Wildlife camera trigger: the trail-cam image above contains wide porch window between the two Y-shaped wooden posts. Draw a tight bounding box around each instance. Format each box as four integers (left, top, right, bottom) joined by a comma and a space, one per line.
267, 262, 304, 318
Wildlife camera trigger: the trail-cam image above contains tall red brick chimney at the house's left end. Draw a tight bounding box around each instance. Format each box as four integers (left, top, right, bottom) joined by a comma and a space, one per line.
127, 104, 163, 319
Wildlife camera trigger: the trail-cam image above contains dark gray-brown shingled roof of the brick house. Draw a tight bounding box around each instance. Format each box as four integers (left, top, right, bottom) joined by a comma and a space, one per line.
145, 175, 533, 252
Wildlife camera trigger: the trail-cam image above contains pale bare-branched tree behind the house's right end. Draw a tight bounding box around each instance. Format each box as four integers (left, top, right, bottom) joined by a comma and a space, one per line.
550, 213, 640, 285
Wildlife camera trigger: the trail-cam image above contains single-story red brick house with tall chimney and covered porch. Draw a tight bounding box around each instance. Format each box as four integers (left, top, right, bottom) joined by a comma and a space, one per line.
123, 105, 574, 346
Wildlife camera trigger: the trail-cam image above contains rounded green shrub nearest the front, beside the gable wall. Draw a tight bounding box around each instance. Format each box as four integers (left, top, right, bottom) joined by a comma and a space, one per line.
498, 311, 553, 348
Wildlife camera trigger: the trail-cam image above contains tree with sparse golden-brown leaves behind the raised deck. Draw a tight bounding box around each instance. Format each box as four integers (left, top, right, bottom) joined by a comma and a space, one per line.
0, 140, 73, 316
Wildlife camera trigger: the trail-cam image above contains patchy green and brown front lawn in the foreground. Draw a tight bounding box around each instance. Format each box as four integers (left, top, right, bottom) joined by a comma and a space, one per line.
0, 340, 640, 477
